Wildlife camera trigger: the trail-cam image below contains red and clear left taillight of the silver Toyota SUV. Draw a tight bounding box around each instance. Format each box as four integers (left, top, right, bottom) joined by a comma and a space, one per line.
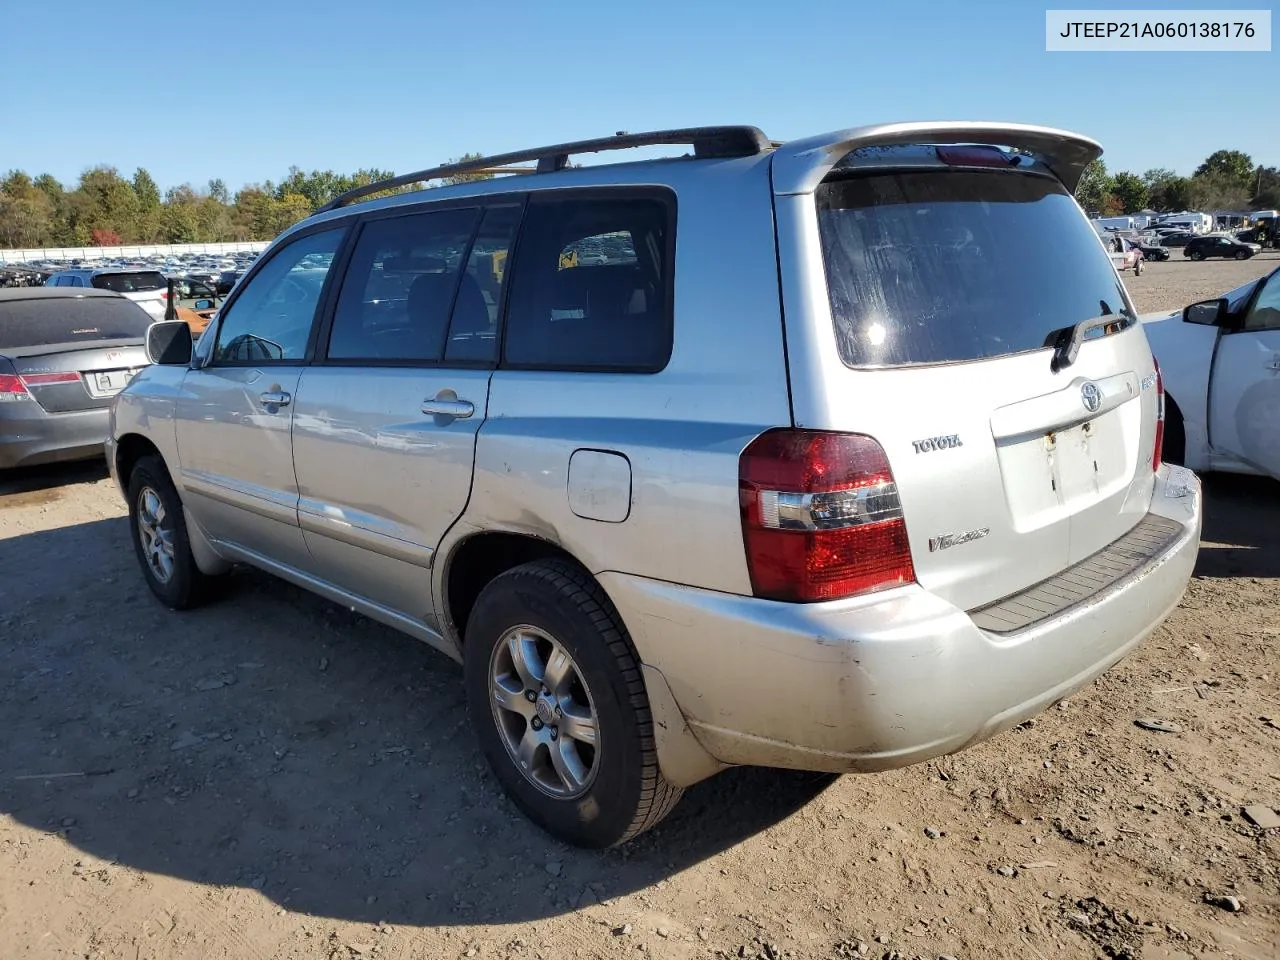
739, 430, 915, 602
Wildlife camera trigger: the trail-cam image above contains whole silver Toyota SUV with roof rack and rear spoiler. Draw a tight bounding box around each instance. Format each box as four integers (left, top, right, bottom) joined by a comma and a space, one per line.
108, 123, 1201, 846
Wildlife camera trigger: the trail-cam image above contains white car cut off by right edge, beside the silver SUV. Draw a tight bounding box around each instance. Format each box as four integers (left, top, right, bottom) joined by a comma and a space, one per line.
1142, 269, 1280, 480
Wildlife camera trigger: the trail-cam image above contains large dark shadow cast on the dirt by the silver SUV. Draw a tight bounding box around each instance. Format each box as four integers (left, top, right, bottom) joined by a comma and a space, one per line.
0, 520, 832, 925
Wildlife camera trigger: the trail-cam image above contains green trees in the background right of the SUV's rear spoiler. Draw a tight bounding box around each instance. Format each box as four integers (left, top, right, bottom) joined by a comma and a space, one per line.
1075, 150, 1280, 216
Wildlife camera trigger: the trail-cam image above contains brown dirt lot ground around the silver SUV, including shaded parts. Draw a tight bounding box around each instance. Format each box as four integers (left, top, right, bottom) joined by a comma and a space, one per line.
0, 255, 1280, 960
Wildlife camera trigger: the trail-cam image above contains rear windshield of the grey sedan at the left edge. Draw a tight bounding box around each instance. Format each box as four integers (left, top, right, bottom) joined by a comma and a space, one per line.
0, 297, 151, 352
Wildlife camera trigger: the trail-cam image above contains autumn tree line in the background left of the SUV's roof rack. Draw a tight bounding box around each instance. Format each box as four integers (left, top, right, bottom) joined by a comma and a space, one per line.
0, 154, 492, 247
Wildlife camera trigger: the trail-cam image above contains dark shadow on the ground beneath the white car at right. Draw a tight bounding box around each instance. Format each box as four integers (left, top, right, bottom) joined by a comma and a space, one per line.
1196, 474, 1280, 577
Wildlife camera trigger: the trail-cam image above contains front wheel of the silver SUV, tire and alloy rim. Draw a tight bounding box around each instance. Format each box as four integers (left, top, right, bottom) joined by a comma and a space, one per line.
129, 456, 223, 611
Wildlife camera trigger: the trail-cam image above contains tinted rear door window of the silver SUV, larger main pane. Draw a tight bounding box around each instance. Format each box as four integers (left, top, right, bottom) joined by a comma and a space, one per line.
329, 207, 480, 361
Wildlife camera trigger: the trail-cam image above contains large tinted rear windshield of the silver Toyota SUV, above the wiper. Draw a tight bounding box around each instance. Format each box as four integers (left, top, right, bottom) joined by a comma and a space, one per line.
817, 170, 1132, 366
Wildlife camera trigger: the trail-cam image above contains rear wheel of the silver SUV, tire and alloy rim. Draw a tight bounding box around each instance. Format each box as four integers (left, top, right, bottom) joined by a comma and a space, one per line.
463, 561, 682, 849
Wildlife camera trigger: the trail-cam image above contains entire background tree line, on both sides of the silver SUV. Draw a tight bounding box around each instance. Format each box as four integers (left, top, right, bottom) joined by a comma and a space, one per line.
0, 150, 1280, 247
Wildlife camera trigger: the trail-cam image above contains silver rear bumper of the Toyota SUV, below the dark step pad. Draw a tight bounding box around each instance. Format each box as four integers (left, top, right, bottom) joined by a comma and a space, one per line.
600, 467, 1201, 772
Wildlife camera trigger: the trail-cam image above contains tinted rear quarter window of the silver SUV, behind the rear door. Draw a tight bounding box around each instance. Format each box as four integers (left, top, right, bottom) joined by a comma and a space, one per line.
503, 192, 675, 372
